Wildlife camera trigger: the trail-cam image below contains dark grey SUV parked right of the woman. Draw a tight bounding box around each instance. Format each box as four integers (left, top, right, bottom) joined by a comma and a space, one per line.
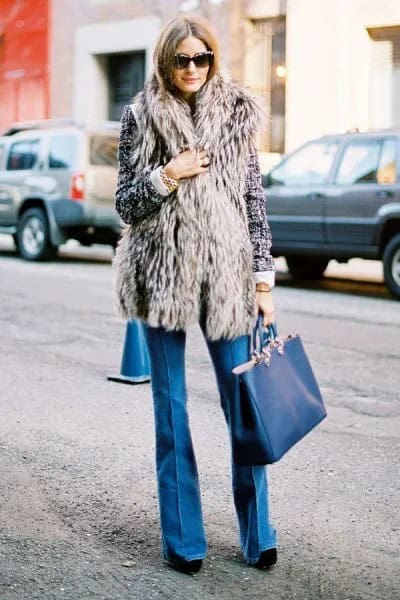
263, 131, 400, 299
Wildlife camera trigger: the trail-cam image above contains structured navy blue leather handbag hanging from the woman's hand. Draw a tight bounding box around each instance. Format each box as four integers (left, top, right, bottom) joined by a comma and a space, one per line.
230, 317, 326, 465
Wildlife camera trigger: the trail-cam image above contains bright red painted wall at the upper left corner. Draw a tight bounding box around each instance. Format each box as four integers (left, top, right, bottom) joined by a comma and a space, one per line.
0, 0, 50, 132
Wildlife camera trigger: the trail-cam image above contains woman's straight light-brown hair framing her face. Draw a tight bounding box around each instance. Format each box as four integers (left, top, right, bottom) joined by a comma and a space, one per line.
153, 17, 219, 91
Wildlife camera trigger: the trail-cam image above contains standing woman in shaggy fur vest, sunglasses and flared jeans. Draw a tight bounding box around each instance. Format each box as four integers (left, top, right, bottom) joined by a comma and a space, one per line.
115, 17, 277, 573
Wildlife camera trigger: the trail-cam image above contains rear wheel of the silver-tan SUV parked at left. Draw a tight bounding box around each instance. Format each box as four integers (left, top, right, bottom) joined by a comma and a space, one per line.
17, 208, 57, 260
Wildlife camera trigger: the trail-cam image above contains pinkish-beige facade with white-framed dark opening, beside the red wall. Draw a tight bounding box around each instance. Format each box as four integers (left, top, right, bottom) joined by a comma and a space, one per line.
51, 0, 244, 120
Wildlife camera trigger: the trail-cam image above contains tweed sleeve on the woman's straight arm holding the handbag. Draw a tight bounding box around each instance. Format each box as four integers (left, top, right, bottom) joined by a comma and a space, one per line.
245, 150, 275, 272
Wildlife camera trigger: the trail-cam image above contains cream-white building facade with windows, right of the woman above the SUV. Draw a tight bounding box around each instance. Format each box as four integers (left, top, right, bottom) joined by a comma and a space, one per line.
234, 0, 400, 153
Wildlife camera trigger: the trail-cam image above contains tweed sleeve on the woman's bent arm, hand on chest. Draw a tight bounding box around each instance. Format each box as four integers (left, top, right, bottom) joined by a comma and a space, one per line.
115, 106, 165, 224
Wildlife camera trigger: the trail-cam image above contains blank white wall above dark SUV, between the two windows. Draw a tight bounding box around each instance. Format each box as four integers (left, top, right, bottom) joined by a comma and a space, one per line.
286, 0, 400, 151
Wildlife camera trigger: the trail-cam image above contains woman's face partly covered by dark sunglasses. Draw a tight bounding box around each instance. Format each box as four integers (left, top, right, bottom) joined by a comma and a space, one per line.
172, 36, 210, 100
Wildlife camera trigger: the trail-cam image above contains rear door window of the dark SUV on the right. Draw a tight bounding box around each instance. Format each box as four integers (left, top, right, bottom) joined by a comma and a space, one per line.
336, 139, 381, 185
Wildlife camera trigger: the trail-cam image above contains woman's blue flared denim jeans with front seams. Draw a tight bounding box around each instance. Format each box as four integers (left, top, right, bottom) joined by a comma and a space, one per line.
144, 323, 276, 564
